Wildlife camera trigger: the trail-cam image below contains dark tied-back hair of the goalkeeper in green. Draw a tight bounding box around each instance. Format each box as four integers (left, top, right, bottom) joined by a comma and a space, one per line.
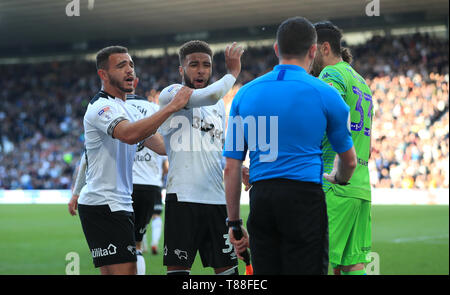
314, 21, 352, 63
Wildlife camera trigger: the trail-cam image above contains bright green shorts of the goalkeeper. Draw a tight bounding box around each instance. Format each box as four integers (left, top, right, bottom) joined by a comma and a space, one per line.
326, 188, 372, 268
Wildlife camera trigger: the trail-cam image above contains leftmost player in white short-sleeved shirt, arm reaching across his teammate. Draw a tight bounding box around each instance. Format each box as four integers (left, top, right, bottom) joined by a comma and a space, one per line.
69, 46, 192, 274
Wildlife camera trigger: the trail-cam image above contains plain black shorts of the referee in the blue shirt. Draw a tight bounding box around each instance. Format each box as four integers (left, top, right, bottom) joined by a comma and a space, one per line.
247, 179, 328, 275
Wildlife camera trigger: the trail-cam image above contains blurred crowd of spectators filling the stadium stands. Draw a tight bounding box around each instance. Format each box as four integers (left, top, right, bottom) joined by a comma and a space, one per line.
0, 34, 449, 189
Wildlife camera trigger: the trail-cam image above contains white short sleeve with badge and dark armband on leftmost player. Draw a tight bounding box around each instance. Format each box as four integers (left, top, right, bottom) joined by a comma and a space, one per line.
85, 100, 128, 137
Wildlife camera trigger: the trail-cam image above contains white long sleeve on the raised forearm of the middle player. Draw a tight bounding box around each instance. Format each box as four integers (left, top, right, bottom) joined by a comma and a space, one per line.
186, 74, 236, 108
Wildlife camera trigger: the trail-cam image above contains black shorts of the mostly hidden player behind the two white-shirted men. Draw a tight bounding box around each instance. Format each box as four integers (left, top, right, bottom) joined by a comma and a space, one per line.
131, 184, 161, 242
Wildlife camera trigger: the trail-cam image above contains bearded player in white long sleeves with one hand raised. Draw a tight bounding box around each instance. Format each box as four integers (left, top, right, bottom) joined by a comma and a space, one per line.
159, 41, 243, 275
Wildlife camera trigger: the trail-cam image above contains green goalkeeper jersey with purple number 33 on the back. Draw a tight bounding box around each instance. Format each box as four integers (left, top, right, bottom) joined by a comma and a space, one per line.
319, 61, 373, 201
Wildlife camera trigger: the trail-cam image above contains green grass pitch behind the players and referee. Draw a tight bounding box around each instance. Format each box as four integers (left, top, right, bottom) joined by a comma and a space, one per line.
0, 205, 449, 275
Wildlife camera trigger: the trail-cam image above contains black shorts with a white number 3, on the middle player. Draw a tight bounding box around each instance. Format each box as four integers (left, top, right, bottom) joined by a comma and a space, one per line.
163, 194, 238, 268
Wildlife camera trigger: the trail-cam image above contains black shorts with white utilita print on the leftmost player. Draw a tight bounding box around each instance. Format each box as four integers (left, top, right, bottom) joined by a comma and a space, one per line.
78, 204, 136, 267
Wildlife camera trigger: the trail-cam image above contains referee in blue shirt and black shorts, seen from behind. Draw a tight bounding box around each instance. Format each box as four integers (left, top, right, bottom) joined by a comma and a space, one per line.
223, 17, 356, 275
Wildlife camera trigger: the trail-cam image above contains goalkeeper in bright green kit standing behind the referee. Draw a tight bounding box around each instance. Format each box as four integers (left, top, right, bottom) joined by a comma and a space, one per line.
312, 22, 373, 275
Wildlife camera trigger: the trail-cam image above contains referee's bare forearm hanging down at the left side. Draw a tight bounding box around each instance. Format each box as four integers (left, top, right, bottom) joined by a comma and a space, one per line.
224, 158, 242, 220
